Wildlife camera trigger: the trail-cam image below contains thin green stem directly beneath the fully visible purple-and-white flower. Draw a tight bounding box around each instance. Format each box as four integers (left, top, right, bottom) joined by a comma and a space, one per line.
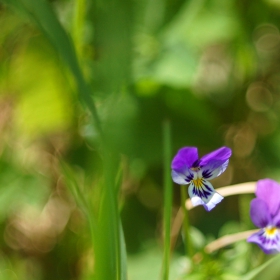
181, 185, 193, 258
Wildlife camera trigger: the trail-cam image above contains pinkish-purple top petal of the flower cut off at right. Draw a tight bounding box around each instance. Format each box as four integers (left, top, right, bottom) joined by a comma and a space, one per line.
256, 179, 280, 216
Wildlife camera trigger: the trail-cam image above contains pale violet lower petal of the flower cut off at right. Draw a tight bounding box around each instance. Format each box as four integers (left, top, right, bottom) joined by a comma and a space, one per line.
247, 229, 280, 254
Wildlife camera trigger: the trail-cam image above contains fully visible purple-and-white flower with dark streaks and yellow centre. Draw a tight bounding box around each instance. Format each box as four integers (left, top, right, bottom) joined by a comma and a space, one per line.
171, 147, 231, 211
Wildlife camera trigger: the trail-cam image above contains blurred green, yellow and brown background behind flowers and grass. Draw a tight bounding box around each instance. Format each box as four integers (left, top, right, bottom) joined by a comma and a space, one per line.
0, 0, 280, 280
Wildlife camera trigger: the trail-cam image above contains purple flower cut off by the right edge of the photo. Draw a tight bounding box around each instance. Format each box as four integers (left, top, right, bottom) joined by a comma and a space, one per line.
247, 179, 280, 254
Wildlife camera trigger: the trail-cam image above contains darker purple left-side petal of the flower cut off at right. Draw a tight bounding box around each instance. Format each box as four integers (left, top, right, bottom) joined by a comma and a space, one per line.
250, 198, 272, 228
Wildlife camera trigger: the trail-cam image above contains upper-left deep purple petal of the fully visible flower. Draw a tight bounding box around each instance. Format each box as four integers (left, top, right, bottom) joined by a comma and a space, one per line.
171, 147, 198, 173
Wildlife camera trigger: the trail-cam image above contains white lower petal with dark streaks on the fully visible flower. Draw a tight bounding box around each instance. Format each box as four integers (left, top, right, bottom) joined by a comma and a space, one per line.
188, 180, 223, 211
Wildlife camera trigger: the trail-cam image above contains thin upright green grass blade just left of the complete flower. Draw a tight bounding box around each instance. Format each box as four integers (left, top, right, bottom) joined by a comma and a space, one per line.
161, 121, 173, 280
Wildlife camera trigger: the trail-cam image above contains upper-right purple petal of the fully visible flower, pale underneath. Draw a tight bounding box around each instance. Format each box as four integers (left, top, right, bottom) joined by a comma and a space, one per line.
200, 147, 231, 179
